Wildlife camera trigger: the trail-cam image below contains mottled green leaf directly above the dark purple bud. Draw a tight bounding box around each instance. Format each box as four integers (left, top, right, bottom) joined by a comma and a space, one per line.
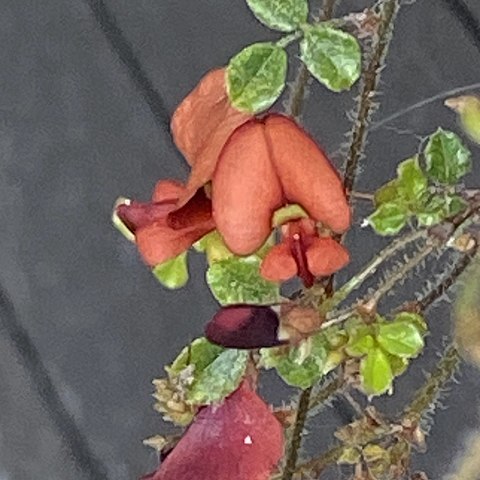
207, 255, 280, 305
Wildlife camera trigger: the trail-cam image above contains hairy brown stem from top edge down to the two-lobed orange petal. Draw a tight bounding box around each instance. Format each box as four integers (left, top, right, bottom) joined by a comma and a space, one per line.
343, 0, 400, 195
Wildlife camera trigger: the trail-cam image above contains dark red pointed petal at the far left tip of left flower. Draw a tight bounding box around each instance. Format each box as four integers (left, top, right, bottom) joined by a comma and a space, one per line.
116, 201, 172, 233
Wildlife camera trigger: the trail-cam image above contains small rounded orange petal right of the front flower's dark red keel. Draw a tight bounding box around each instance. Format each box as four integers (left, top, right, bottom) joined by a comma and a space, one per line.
307, 237, 350, 277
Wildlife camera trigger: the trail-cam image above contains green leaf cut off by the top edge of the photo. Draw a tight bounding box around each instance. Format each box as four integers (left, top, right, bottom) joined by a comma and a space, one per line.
247, 0, 308, 32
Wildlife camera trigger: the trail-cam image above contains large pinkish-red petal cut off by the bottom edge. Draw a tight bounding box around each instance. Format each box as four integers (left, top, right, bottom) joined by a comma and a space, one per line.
144, 381, 283, 480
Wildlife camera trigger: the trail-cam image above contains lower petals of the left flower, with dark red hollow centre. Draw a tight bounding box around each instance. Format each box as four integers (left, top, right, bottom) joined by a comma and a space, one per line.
116, 180, 215, 266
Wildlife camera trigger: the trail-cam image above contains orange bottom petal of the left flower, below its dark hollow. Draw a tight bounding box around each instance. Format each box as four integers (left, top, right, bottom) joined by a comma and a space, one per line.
135, 222, 215, 267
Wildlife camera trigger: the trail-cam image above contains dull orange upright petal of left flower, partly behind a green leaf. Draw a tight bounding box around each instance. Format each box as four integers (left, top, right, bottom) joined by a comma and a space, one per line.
171, 68, 251, 204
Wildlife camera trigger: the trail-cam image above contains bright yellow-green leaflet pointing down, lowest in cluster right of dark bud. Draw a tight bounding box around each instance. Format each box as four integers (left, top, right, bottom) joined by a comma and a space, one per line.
360, 348, 393, 395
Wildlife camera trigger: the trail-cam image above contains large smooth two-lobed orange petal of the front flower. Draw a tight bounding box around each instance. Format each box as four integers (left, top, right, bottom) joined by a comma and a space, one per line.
212, 114, 350, 255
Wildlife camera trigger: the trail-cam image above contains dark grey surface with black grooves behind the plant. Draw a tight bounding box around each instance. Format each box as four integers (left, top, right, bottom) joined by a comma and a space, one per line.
0, 0, 480, 480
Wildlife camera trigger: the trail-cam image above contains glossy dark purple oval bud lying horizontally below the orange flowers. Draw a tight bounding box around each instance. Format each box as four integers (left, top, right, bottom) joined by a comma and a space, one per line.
205, 305, 285, 349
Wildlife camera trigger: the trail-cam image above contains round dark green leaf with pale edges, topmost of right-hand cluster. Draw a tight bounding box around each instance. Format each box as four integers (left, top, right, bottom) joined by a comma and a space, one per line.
425, 128, 472, 185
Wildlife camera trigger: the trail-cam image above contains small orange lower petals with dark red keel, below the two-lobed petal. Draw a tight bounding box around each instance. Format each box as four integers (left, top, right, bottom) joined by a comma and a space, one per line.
260, 218, 349, 287
